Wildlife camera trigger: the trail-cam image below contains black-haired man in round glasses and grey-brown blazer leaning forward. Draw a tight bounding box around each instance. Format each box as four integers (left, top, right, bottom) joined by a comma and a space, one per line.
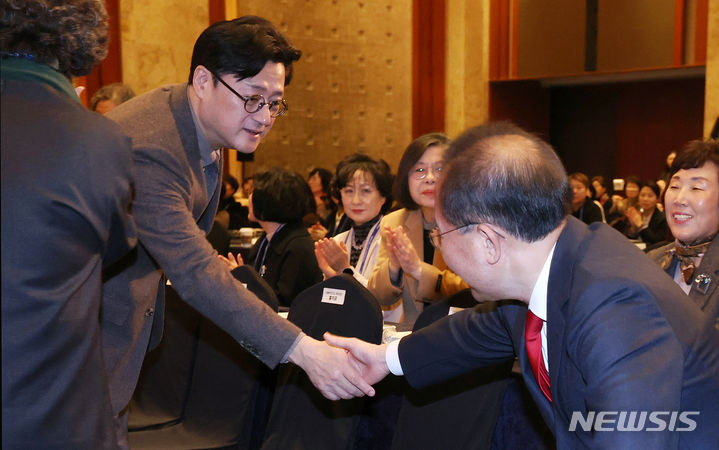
102, 16, 374, 446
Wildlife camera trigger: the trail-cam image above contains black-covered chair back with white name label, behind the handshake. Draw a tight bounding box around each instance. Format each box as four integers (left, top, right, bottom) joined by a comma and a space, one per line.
262, 274, 382, 450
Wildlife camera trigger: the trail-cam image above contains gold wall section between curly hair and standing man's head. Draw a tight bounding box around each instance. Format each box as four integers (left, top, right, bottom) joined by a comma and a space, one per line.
120, 0, 209, 94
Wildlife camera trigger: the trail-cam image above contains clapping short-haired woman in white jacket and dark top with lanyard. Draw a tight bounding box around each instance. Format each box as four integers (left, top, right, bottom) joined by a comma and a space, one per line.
315, 153, 392, 286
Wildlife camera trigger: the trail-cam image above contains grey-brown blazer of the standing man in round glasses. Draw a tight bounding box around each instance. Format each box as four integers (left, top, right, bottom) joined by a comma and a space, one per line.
102, 84, 300, 413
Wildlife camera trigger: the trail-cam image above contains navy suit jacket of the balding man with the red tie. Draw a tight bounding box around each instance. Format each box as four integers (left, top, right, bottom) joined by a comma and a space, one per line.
399, 217, 719, 448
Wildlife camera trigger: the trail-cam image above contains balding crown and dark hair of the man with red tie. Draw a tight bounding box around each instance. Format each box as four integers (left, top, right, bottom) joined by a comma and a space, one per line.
439, 122, 572, 242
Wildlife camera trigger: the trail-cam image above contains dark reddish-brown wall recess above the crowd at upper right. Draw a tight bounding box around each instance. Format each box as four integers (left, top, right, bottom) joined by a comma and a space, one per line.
550, 78, 704, 180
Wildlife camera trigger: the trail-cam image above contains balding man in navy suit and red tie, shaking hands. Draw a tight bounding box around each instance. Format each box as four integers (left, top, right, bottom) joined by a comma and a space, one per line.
327, 124, 719, 448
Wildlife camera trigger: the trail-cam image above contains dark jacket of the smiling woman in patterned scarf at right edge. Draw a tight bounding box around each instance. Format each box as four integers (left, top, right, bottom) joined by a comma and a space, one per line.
648, 237, 719, 329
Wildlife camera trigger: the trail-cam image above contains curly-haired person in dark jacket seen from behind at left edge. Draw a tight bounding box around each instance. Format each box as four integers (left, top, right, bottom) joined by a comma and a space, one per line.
0, 0, 136, 449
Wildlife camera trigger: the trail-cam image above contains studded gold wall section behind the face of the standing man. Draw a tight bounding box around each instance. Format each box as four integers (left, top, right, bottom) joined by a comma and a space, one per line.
231, 0, 412, 175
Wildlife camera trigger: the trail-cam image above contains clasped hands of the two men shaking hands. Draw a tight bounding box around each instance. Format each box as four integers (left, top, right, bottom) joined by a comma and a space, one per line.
289, 333, 390, 400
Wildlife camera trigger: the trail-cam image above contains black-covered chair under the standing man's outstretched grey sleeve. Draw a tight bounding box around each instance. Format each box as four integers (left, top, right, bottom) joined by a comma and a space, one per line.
129, 266, 278, 449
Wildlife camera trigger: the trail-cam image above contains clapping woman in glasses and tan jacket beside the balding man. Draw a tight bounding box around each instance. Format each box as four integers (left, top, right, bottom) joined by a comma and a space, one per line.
367, 133, 468, 328
